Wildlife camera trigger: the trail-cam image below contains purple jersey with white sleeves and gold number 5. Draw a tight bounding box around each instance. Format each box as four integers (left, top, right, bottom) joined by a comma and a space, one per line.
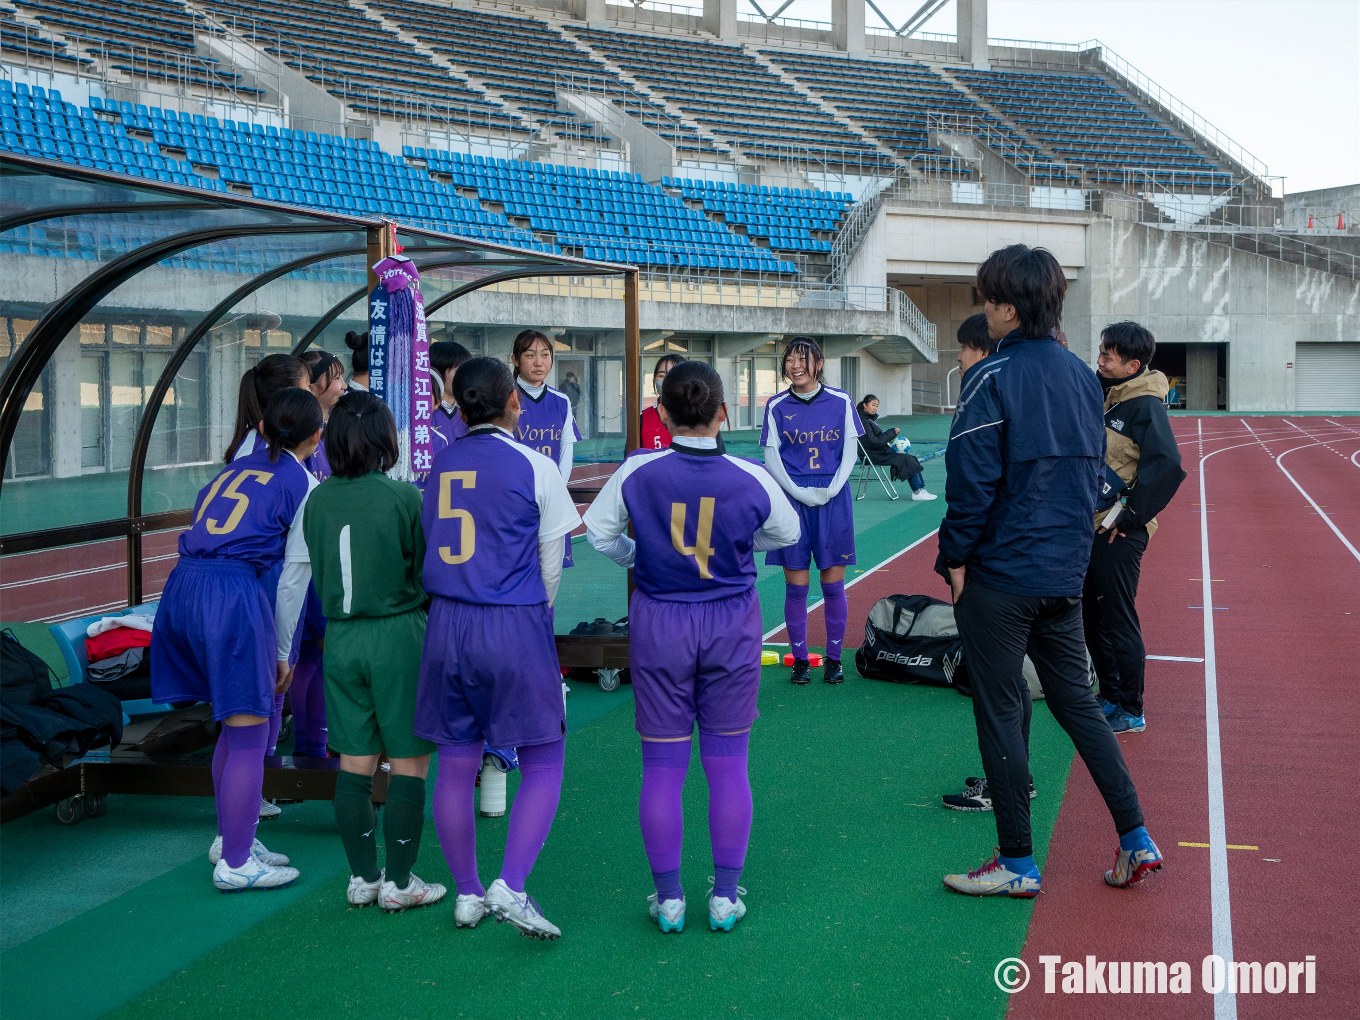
420, 426, 581, 606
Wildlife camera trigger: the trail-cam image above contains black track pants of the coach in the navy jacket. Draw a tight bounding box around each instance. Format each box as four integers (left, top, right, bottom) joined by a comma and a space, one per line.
953, 581, 1142, 857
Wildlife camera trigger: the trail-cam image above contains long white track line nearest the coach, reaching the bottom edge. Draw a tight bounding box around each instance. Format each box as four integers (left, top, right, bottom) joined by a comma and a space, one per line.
1200, 419, 1238, 1020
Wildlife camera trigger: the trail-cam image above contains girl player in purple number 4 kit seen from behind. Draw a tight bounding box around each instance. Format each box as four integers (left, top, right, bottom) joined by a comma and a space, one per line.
586, 362, 798, 932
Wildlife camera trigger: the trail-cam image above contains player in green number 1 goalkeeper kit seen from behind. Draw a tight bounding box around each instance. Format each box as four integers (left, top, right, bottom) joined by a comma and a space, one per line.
299, 393, 445, 911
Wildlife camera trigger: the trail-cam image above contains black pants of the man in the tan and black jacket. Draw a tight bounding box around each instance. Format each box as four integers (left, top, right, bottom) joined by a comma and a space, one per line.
1081, 528, 1148, 715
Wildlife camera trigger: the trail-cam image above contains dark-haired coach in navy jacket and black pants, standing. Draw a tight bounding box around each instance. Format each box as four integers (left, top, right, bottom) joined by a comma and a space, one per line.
937, 245, 1161, 896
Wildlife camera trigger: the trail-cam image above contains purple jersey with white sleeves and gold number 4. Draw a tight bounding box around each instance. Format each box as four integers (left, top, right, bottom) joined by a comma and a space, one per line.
585, 435, 798, 602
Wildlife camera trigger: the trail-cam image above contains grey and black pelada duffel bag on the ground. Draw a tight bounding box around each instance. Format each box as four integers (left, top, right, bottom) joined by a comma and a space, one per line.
854, 596, 970, 695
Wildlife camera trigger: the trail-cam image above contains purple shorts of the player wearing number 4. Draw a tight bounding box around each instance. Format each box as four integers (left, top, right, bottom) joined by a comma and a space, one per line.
628, 588, 760, 737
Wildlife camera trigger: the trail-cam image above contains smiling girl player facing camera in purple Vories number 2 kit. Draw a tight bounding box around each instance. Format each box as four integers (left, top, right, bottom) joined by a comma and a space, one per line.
760, 336, 864, 684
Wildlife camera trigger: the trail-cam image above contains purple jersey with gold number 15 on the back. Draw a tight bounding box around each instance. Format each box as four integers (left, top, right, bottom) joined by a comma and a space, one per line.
180, 446, 318, 575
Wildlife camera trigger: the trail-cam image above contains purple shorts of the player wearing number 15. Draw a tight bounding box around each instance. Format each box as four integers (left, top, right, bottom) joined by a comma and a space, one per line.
151, 556, 276, 722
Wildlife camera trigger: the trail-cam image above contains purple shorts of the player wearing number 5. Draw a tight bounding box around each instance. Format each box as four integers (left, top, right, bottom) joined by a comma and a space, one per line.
415, 596, 567, 747
